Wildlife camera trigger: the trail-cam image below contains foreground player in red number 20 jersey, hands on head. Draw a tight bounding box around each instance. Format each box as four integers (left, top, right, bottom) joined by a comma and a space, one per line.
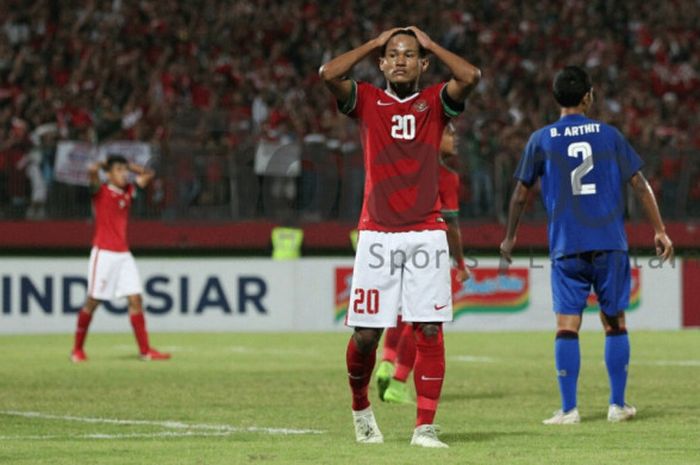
319, 26, 481, 447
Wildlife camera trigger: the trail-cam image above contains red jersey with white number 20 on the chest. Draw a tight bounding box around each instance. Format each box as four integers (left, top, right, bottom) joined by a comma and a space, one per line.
341, 82, 458, 232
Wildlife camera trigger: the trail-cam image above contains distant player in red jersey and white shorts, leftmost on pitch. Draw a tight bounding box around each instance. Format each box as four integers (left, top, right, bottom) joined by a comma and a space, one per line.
71, 155, 170, 363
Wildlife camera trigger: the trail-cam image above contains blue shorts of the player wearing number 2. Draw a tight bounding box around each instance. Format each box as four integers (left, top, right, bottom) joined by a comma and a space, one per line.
552, 250, 632, 316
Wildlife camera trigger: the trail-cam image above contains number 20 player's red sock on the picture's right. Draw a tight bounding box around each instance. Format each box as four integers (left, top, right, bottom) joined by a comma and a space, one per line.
413, 325, 445, 426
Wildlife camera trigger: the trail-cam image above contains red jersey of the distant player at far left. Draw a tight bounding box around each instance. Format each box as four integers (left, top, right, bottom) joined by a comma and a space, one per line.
92, 184, 136, 252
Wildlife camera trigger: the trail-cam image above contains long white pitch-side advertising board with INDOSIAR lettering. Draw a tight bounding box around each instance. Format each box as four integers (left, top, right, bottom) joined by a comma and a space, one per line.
0, 255, 681, 334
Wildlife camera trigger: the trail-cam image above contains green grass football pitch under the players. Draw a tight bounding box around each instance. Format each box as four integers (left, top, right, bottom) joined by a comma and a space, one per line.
0, 331, 700, 465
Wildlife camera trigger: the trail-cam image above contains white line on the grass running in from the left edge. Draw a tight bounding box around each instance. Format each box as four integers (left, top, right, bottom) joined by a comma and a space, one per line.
0, 410, 324, 435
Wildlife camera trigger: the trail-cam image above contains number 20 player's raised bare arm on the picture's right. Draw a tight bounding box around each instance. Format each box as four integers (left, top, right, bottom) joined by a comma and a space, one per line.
408, 26, 481, 104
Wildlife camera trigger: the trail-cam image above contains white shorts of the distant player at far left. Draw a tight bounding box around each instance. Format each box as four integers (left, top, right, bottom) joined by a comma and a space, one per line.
88, 247, 143, 300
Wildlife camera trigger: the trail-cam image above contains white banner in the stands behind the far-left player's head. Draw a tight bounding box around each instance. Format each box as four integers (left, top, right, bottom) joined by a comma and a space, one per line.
54, 140, 152, 186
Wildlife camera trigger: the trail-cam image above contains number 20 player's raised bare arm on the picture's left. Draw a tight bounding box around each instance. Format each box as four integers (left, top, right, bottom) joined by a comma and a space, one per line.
318, 28, 401, 103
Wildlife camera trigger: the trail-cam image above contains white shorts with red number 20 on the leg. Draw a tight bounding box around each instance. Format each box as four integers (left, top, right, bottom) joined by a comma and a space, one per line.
345, 230, 452, 328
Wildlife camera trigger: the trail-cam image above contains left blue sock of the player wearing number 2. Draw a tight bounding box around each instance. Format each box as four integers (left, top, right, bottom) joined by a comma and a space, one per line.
554, 331, 581, 412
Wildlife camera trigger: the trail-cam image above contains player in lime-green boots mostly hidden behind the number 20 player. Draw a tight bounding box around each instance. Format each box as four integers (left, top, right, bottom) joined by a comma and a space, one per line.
376, 123, 469, 404
